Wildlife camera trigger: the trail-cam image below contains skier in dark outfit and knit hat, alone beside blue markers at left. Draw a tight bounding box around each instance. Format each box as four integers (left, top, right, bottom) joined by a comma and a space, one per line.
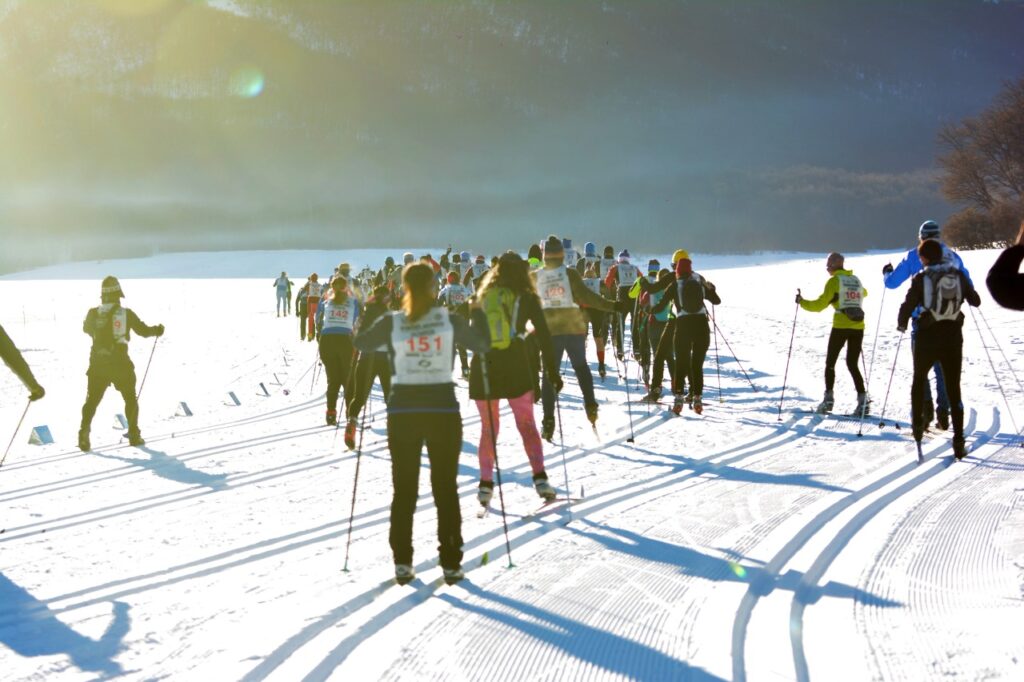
78, 276, 164, 453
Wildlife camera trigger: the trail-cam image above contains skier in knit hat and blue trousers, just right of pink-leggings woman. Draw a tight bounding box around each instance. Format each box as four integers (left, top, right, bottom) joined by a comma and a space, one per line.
532, 236, 615, 440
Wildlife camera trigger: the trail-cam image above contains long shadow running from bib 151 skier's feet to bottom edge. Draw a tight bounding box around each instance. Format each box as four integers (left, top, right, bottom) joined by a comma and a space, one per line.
437, 582, 722, 682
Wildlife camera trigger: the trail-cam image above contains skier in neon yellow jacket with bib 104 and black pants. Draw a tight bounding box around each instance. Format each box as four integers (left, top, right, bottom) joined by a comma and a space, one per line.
797, 252, 868, 416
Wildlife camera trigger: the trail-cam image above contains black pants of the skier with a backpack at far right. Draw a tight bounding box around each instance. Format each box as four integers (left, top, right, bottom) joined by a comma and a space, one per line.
910, 323, 964, 440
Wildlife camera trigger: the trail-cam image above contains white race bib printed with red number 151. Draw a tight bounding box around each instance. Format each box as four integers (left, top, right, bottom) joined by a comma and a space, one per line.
391, 308, 455, 385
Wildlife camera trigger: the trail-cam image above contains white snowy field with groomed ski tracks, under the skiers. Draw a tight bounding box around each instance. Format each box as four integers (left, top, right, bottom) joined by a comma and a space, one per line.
0, 245, 1024, 681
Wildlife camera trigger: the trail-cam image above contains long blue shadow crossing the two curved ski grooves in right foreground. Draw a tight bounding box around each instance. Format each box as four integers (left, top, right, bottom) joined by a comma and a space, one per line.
566, 520, 903, 608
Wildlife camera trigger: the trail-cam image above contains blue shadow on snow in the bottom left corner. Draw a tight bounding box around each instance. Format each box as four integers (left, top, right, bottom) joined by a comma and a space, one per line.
0, 572, 131, 677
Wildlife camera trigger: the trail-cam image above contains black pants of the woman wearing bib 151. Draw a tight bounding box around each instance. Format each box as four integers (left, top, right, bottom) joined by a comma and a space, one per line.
387, 413, 462, 568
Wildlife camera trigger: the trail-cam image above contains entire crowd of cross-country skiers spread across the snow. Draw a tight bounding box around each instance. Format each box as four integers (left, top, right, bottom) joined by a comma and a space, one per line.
0, 221, 1024, 583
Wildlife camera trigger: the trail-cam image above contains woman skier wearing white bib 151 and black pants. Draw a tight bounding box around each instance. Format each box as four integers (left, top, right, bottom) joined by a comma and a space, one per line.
355, 263, 490, 585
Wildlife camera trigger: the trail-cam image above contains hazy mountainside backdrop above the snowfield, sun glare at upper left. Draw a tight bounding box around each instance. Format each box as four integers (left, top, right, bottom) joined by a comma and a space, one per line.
0, 0, 1024, 272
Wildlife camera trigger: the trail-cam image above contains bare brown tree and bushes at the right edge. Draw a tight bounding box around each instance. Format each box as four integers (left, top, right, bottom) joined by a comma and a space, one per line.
939, 78, 1024, 249
